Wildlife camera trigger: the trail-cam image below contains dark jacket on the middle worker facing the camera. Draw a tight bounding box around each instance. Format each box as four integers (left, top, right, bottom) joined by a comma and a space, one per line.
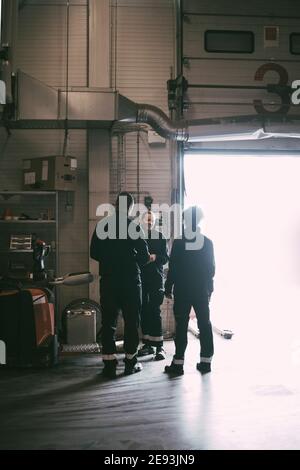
142, 229, 169, 282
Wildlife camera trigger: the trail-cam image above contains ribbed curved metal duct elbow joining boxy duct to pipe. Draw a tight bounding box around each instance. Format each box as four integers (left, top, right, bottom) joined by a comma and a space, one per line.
136, 104, 188, 142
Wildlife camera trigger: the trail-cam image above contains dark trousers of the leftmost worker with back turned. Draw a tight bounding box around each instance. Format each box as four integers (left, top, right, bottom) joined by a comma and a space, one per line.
100, 279, 141, 360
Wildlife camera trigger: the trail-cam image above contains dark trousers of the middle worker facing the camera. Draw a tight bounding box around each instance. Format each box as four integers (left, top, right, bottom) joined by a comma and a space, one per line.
141, 280, 164, 346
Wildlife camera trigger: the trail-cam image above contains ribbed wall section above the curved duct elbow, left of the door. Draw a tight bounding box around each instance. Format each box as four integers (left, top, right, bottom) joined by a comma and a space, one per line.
113, 1, 174, 94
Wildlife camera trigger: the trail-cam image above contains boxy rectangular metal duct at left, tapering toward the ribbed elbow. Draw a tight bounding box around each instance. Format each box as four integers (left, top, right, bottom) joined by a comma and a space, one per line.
1, 70, 137, 129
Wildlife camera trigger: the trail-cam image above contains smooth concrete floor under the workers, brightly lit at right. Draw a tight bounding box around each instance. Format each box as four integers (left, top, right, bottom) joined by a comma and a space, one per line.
0, 336, 300, 450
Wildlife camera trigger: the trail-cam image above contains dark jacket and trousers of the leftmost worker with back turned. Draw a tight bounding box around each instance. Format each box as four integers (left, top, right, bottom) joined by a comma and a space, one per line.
90, 215, 149, 361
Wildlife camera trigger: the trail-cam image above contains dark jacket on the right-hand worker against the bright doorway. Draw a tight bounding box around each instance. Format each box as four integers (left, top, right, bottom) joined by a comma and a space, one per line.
165, 237, 215, 295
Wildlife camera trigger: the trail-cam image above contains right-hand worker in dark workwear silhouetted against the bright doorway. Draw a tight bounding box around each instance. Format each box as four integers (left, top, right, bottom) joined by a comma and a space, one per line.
165, 207, 215, 375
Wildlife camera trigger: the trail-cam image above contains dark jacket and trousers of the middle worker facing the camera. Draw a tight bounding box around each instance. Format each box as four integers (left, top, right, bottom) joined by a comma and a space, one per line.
142, 229, 168, 346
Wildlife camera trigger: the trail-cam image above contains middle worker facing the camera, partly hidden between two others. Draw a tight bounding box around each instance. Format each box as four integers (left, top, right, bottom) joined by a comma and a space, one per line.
138, 211, 168, 361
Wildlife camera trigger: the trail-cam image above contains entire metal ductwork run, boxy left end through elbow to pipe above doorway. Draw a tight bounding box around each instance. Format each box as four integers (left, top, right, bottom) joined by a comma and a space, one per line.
1, 71, 300, 143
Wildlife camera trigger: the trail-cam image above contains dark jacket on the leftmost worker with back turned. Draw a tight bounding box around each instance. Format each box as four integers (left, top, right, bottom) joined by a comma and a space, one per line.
90, 213, 150, 280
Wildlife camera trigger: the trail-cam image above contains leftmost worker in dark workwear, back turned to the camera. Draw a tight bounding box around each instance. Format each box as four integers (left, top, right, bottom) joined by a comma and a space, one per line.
90, 192, 150, 378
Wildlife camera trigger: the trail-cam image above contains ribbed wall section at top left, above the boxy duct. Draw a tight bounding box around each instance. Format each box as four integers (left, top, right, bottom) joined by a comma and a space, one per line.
17, 2, 88, 87
